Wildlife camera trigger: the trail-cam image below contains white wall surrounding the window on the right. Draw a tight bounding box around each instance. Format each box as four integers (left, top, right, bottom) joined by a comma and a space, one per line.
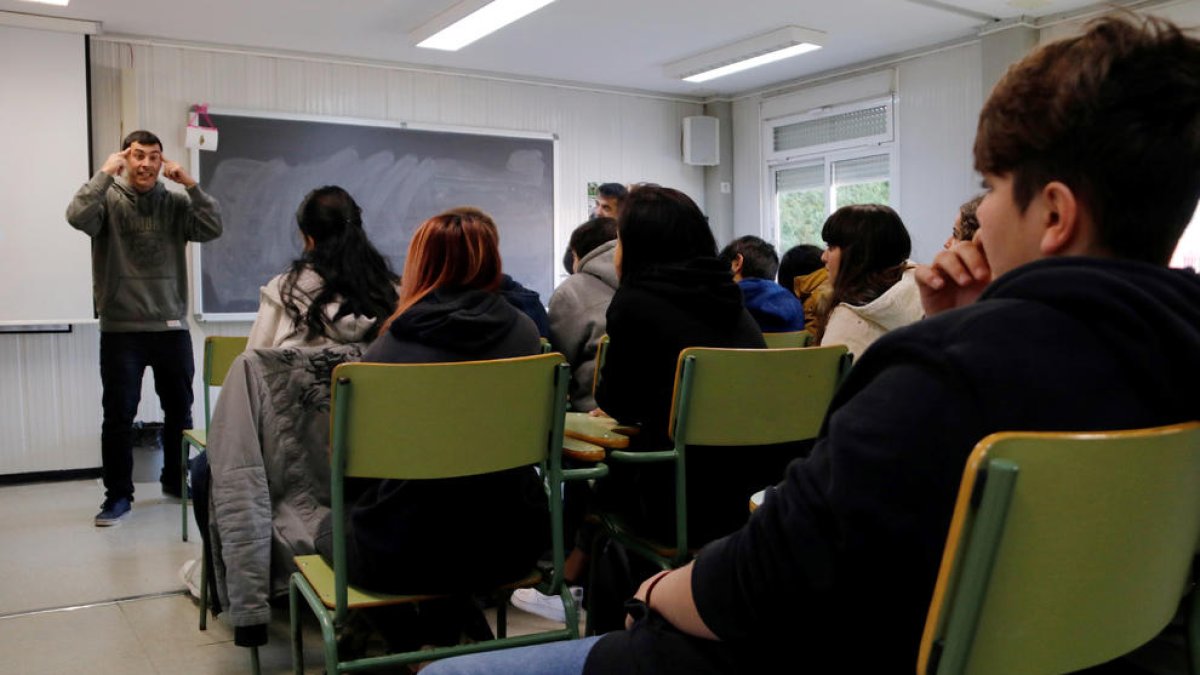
733, 42, 983, 262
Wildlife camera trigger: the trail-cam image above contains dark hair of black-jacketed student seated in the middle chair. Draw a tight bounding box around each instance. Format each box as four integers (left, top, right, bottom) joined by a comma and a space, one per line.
617, 184, 716, 283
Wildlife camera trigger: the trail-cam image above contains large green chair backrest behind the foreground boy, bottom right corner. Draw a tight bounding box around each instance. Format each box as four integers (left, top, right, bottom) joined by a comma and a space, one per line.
917, 423, 1200, 674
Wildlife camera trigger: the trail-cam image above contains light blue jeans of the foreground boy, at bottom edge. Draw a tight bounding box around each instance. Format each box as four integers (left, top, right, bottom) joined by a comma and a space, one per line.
421, 635, 600, 675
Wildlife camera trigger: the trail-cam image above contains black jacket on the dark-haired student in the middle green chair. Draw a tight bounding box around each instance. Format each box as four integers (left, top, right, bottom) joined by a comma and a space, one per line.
596, 258, 768, 545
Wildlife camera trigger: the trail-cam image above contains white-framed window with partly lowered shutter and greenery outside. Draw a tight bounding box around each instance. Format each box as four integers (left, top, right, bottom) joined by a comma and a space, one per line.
763, 97, 894, 253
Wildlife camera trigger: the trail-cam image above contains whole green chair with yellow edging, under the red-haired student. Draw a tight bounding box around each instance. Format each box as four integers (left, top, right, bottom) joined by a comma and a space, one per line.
289, 353, 578, 674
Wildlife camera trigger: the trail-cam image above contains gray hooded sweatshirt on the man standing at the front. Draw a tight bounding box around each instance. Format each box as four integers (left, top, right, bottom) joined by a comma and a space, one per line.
67, 172, 221, 333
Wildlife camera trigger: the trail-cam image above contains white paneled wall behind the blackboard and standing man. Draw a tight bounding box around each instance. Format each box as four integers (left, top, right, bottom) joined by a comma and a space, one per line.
0, 40, 704, 474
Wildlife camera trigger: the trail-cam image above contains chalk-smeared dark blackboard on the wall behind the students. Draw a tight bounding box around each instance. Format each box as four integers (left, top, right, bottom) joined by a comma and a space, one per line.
192, 112, 556, 321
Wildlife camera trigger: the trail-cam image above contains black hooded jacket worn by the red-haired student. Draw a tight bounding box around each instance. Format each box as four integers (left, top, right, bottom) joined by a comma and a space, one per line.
322, 289, 548, 593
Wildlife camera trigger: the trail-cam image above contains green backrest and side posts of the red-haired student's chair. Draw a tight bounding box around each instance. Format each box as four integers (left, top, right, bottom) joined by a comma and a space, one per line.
330, 353, 570, 621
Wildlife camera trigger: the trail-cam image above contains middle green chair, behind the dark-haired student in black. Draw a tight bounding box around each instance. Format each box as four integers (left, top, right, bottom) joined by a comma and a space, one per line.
599, 345, 852, 569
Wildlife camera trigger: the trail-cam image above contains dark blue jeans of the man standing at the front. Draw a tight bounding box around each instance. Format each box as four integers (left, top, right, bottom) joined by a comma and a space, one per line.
100, 330, 196, 500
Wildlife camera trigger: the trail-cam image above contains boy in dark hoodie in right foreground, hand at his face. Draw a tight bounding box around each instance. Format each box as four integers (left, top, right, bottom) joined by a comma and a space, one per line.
424, 18, 1200, 675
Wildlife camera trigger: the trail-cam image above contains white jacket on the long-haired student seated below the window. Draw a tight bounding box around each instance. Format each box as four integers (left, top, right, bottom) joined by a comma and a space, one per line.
821, 268, 925, 359
